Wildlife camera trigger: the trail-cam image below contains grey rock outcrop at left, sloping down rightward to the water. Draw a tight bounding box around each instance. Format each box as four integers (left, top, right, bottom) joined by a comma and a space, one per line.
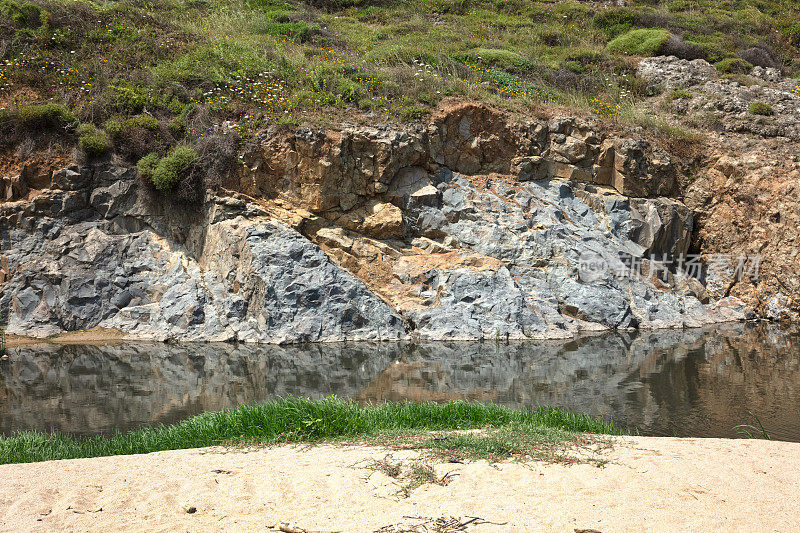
0, 168, 405, 342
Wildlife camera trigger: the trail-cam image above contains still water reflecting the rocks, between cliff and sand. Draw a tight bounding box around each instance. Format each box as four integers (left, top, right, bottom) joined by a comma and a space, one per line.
0, 325, 800, 441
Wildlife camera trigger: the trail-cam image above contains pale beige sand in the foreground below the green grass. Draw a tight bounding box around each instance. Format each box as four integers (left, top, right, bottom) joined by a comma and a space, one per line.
0, 437, 800, 532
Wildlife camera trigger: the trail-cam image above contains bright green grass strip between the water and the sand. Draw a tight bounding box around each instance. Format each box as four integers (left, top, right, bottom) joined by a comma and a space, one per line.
0, 398, 620, 464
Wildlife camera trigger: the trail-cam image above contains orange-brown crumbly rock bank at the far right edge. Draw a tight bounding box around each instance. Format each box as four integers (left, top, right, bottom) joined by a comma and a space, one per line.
639, 57, 800, 321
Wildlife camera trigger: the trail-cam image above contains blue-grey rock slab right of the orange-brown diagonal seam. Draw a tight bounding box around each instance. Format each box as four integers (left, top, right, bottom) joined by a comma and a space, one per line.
404, 175, 733, 339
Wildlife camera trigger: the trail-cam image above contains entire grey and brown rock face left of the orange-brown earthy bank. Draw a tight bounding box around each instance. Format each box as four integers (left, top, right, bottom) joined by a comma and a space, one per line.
0, 105, 746, 343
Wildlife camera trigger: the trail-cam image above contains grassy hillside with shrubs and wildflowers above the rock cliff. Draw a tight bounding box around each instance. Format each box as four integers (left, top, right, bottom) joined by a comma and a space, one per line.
0, 0, 800, 178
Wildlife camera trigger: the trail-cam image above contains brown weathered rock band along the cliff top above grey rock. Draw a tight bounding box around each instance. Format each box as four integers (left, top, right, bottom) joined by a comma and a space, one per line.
233, 104, 677, 213
